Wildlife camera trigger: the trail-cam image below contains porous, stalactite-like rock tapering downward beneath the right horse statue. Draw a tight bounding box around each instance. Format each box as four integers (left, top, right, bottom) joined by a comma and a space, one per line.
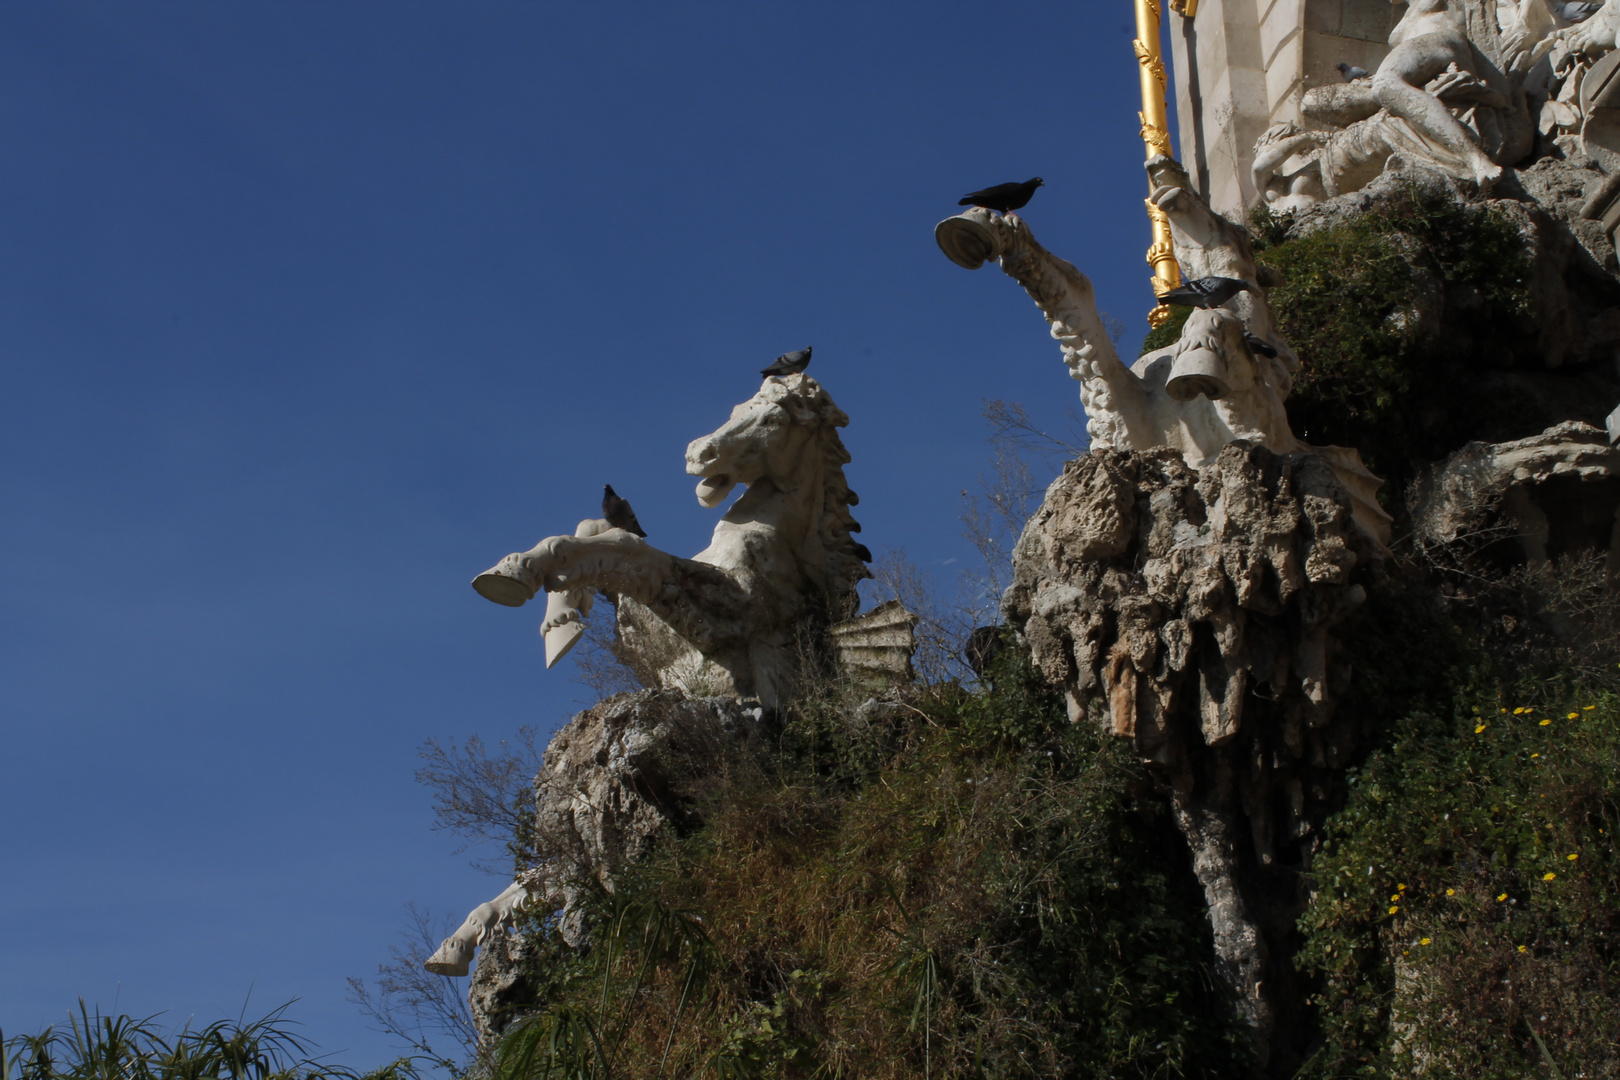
1003, 442, 1382, 1056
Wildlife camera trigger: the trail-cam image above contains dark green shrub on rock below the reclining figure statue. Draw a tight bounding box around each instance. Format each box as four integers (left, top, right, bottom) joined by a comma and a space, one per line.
1254, 185, 1529, 486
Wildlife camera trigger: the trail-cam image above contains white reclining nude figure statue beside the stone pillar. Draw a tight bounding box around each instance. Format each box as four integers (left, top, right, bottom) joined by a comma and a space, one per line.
1252, 0, 1560, 210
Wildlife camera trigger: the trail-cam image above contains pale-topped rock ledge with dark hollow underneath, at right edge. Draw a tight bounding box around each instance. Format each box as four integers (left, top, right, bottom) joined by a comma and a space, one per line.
1408, 421, 1620, 573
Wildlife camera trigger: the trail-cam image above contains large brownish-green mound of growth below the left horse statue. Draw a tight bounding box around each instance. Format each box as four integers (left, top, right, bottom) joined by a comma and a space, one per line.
501, 651, 1246, 1078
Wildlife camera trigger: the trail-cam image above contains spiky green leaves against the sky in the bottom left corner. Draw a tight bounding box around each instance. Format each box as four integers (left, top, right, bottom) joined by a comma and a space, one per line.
0, 1001, 420, 1080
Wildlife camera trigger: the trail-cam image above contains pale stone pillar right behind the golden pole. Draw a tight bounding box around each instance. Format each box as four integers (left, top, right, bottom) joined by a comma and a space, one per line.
1168, 0, 1401, 217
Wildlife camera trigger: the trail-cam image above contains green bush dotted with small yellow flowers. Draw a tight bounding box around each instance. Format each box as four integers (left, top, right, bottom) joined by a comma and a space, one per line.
1296, 685, 1620, 1080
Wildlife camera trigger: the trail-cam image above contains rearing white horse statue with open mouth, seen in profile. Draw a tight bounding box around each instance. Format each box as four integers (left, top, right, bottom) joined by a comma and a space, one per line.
473, 374, 872, 706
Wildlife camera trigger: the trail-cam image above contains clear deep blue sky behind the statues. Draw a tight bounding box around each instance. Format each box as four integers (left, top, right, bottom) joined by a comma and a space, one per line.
0, 0, 1179, 1067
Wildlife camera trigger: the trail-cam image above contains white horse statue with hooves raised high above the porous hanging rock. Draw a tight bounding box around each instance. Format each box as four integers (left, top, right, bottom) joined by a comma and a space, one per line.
935, 157, 1390, 544
